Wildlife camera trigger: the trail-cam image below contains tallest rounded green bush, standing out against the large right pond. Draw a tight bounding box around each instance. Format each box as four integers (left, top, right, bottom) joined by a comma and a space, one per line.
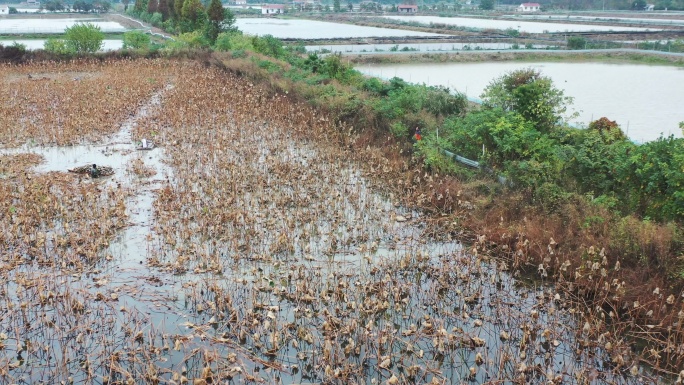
481, 68, 572, 132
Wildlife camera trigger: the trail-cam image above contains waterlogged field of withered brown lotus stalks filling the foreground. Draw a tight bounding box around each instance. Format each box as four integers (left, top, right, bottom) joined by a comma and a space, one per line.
0, 60, 672, 384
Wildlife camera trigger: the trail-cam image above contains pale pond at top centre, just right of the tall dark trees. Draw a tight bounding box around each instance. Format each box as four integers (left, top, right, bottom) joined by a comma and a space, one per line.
235, 18, 444, 39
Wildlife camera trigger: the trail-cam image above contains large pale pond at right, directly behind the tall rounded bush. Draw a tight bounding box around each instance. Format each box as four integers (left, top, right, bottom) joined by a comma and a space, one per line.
357, 62, 684, 142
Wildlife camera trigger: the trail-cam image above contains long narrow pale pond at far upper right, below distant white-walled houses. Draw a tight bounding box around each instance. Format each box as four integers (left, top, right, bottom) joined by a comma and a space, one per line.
383, 16, 658, 33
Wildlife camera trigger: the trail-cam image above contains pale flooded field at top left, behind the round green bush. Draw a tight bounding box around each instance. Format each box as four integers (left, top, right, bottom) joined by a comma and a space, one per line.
0, 18, 126, 35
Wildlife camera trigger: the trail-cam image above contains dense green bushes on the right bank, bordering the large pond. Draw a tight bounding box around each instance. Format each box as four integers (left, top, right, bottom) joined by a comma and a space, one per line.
436, 70, 684, 221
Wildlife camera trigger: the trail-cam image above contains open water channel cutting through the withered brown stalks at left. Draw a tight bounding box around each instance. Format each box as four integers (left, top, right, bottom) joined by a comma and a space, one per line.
0, 85, 184, 383
